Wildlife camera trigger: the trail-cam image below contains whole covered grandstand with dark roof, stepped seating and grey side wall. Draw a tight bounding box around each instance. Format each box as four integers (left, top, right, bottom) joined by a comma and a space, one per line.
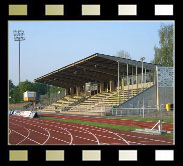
35, 53, 173, 115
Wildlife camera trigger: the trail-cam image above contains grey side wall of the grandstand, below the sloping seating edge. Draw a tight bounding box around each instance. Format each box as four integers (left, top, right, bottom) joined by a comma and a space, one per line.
119, 86, 173, 108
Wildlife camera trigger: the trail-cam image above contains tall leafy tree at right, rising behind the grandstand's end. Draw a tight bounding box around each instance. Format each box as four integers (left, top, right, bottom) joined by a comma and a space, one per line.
152, 24, 173, 66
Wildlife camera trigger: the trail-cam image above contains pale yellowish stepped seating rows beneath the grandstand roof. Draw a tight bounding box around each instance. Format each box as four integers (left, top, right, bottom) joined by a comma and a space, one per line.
44, 82, 154, 112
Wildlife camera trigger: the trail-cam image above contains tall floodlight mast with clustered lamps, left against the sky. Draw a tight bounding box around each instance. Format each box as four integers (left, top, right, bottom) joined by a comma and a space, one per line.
13, 30, 25, 85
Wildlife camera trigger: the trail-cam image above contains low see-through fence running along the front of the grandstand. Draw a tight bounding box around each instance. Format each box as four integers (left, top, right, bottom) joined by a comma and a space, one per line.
38, 105, 174, 119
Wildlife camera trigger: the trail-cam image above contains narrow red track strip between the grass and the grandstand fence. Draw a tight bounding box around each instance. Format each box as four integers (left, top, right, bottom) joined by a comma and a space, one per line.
41, 113, 173, 131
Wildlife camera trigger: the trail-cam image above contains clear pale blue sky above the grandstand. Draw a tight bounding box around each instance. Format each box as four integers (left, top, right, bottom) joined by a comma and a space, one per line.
9, 21, 173, 85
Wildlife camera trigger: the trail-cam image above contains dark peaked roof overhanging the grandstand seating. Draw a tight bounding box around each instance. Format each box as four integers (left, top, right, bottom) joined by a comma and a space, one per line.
34, 53, 156, 88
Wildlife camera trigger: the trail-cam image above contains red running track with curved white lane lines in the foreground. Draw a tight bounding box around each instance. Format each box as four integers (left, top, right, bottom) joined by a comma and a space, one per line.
9, 115, 173, 145
